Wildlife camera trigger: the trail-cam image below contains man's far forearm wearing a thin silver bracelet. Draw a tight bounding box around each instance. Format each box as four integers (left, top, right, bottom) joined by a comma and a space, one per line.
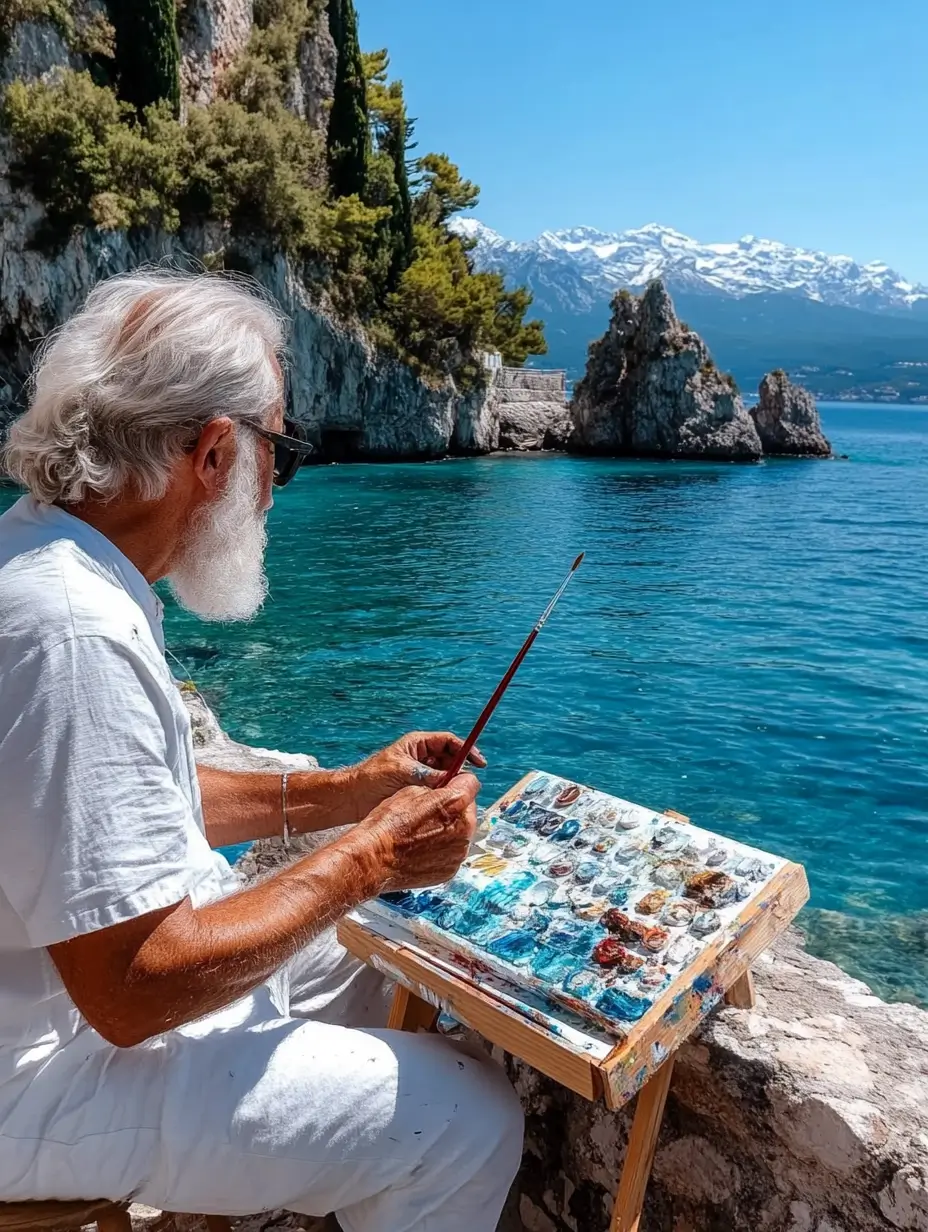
197, 765, 359, 848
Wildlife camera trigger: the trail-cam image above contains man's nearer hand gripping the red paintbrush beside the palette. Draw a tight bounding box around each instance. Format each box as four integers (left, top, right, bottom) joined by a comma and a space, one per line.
349, 774, 479, 891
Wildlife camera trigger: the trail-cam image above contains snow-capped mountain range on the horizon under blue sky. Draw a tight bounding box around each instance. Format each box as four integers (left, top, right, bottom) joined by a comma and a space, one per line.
455, 218, 928, 313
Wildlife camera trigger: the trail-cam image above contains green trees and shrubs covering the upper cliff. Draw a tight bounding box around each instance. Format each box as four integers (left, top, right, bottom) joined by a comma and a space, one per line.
0, 0, 546, 383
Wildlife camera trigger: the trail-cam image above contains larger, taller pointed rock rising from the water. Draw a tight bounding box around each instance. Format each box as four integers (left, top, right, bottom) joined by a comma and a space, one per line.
569, 281, 762, 462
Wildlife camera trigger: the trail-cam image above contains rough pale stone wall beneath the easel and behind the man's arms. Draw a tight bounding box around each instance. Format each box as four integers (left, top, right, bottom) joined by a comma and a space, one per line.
182, 701, 928, 1232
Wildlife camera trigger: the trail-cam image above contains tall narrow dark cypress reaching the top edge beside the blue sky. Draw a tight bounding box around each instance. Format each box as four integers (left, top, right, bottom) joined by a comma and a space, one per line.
329, 0, 371, 197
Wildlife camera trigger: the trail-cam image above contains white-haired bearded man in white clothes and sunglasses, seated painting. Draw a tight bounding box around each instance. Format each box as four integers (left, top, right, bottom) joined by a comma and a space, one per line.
0, 272, 521, 1232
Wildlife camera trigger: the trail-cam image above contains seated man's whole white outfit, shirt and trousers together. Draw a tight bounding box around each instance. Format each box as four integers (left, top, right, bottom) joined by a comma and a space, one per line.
0, 498, 521, 1232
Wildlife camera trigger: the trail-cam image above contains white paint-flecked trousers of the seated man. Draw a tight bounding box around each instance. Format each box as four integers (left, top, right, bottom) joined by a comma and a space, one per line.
0, 933, 523, 1232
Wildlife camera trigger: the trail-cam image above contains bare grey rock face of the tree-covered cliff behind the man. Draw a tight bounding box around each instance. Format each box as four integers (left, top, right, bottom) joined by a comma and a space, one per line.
0, 0, 499, 460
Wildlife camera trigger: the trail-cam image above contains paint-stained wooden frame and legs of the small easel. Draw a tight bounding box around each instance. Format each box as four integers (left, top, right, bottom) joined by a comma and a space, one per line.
338, 776, 808, 1232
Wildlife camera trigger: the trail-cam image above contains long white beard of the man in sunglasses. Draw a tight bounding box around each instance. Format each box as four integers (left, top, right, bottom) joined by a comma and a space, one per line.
168, 432, 267, 621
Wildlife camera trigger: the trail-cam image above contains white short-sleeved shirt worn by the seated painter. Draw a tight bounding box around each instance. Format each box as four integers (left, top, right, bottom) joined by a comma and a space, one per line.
0, 496, 238, 1094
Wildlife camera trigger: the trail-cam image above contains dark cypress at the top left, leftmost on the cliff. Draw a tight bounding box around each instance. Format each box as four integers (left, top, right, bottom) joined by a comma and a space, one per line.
107, 0, 180, 116
